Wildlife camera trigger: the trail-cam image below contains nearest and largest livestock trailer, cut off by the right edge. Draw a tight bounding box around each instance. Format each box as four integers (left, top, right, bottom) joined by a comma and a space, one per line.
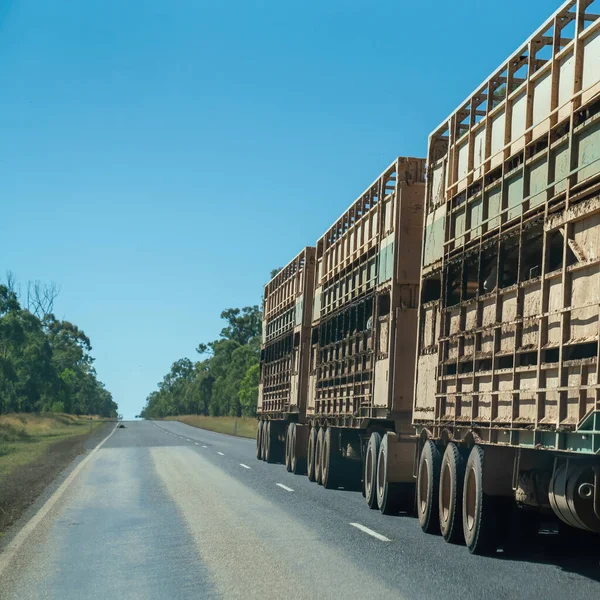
413, 0, 600, 553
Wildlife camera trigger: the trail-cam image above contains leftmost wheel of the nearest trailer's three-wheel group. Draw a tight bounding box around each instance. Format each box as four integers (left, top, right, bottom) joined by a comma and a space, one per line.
417, 440, 442, 533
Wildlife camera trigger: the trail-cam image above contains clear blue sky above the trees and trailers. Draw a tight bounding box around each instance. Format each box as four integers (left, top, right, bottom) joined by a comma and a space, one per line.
0, 0, 559, 417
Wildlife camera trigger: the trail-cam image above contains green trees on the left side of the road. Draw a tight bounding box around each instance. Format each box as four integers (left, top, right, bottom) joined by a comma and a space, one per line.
0, 274, 117, 417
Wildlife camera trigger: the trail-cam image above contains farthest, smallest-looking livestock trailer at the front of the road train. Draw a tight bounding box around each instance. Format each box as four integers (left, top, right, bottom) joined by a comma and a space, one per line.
256, 247, 315, 473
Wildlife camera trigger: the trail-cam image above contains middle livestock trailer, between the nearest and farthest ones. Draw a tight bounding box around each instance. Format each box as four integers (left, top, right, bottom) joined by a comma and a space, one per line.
306, 158, 425, 512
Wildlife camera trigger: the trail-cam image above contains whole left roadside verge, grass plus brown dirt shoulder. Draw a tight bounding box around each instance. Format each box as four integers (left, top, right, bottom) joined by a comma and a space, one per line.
0, 413, 107, 532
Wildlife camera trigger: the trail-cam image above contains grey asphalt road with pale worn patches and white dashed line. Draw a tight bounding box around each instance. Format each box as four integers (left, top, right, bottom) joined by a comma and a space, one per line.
0, 422, 600, 600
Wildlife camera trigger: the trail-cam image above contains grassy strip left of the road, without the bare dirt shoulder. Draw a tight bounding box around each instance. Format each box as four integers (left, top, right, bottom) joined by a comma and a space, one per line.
0, 413, 107, 478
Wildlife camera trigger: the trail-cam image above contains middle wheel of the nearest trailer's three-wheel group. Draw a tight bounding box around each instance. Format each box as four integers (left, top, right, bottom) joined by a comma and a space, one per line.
439, 443, 465, 544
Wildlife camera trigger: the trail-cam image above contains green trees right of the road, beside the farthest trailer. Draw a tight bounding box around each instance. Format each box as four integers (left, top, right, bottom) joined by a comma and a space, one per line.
140, 306, 262, 418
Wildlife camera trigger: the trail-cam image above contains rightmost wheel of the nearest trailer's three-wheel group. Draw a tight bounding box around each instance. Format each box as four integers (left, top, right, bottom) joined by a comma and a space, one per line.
462, 445, 506, 554
